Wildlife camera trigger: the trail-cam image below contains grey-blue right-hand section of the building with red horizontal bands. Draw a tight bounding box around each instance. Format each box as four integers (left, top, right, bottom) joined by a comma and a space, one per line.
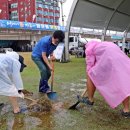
36, 0, 60, 25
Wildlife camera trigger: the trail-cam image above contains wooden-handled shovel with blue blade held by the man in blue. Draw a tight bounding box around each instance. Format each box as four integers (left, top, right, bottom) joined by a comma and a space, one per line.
47, 61, 58, 100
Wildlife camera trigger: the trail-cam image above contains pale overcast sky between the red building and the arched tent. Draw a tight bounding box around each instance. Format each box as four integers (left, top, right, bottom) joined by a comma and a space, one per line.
60, 0, 73, 25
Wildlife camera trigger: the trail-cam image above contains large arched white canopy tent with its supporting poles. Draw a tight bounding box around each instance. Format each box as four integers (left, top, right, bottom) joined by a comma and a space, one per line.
65, 0, 130, 60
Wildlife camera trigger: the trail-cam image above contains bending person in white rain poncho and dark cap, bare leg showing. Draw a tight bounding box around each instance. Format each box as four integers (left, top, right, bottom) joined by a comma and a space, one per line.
0, 52, 26, 113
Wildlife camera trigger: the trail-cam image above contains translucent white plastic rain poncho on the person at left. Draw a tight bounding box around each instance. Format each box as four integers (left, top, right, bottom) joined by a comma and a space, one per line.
0, 54, 23, 97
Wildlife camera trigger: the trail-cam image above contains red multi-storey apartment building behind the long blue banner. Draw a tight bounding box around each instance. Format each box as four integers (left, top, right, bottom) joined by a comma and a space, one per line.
0, 0, 60, 25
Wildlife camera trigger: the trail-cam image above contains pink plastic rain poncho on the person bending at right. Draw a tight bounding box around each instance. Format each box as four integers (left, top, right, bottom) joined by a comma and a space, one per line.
85, 41, 130, 108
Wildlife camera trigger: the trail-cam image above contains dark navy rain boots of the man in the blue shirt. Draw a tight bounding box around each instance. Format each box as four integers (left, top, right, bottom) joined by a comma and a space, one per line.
39, 79, 50, 93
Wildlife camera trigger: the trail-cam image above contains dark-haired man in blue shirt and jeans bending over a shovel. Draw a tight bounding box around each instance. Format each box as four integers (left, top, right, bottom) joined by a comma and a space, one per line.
32, 30, 65, 93
